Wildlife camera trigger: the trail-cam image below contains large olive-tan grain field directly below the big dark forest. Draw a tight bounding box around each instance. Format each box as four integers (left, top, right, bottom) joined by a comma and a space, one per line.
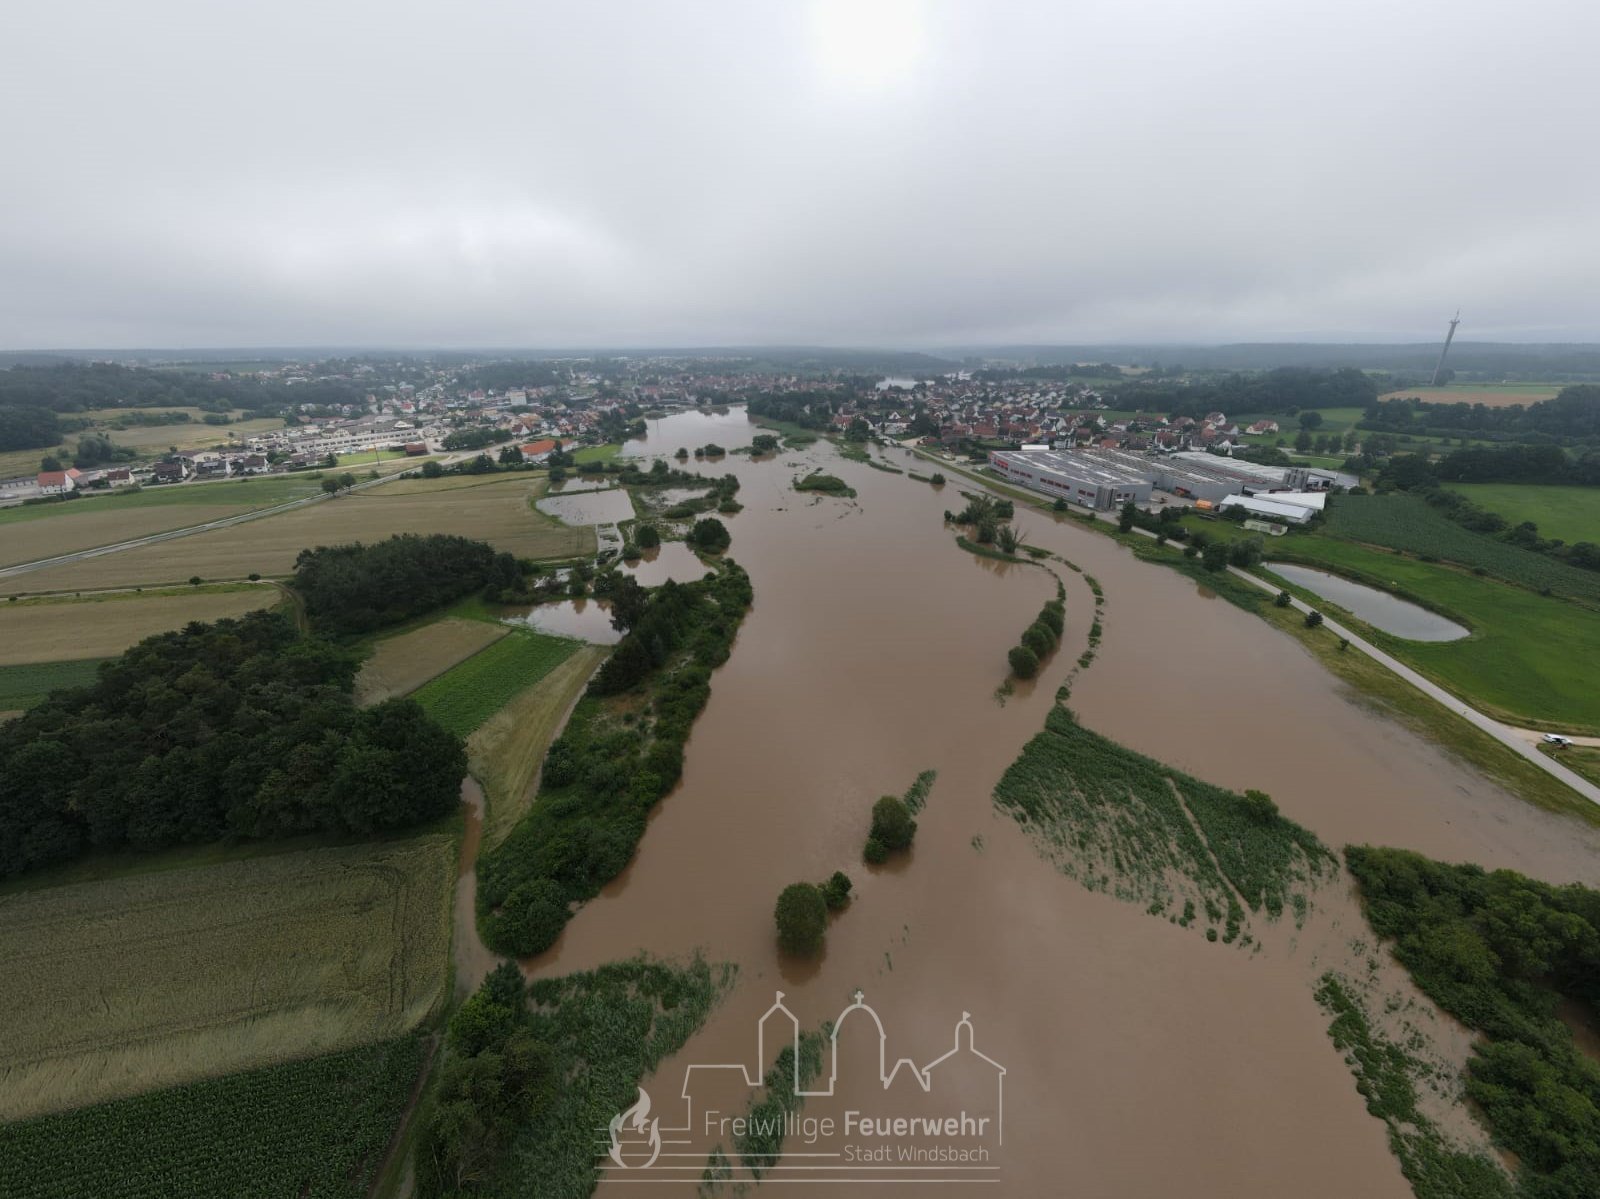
0, 836, 454, 1122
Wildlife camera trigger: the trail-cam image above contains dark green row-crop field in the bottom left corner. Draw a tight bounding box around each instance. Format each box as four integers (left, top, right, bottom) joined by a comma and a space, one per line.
0, 1036, 424, 1199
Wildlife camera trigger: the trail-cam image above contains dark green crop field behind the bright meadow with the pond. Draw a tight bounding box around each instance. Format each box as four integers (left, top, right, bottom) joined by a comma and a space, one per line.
1325, 495, 1600, 604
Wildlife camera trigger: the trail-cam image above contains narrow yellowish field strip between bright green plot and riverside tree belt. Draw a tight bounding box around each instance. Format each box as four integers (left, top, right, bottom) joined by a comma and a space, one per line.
467, 645, 606, 848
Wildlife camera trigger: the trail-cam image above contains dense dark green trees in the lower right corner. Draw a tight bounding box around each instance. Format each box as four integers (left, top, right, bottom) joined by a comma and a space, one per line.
1346, 847, 1600, 1199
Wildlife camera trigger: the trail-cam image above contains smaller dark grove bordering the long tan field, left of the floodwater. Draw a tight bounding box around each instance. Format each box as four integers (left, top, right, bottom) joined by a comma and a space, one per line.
294, 533, 517, 634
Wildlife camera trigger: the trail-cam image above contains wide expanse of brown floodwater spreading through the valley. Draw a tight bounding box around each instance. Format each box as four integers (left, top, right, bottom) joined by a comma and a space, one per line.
492, 410, 1600, 1199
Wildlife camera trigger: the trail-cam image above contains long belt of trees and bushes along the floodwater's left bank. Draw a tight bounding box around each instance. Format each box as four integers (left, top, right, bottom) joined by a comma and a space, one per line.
478, 560, 752, 956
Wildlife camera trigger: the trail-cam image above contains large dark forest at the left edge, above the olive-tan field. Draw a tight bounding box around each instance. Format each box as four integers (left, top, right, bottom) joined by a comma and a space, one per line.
0, 612, 466, 877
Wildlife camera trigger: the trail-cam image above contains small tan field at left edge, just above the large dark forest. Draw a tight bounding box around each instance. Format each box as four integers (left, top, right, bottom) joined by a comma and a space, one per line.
0, 584, 282, 666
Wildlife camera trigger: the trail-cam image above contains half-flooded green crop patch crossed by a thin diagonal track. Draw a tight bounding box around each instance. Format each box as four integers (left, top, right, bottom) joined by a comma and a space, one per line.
995, 706, 1338, 943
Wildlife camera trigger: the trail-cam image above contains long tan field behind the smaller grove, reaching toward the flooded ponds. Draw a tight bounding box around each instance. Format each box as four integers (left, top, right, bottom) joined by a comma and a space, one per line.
13, 475, 595, 592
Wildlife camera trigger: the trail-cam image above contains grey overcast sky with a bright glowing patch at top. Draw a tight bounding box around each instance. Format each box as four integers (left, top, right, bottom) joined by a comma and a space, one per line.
0, 0, 1600, 349
